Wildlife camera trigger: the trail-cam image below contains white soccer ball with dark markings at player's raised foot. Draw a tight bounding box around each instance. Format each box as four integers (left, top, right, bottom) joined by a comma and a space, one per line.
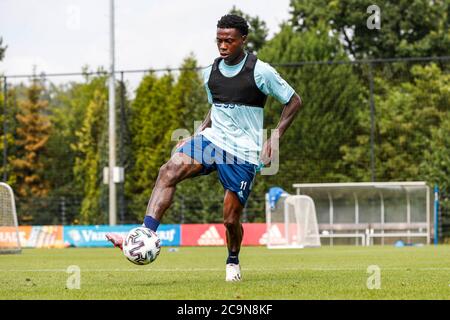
123, 227, 161, 265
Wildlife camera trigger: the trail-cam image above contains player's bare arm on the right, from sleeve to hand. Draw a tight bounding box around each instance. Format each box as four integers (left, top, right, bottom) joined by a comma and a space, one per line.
260, 92, 303, 165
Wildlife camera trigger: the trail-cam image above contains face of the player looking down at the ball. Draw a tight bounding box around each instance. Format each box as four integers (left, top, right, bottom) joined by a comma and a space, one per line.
216, 28, 246, 63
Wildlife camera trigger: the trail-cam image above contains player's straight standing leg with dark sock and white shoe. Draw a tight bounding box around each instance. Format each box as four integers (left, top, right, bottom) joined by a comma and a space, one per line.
223, 190, 244, 281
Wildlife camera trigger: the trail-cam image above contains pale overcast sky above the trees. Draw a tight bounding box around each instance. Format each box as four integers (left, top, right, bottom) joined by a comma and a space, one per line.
0, 0, 290, 86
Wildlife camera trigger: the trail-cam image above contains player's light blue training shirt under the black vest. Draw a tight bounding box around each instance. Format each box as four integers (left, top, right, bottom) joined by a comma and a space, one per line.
199, 53, 295, 165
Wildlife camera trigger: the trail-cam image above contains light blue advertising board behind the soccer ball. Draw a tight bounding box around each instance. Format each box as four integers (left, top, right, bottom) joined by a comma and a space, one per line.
64, 224, 181, 247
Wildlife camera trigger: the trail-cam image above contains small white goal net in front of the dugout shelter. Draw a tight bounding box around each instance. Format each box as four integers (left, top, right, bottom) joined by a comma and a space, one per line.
266, 194, 320, 249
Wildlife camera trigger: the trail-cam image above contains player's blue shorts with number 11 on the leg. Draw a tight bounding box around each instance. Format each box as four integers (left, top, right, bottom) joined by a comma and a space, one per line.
176, 135, 257, 206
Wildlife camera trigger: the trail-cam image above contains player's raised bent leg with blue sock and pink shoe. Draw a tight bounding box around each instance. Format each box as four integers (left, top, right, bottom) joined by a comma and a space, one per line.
106, 152, 203, 250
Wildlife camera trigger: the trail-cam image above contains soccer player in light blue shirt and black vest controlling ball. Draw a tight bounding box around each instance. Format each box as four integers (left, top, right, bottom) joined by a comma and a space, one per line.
107, 14, 302, 281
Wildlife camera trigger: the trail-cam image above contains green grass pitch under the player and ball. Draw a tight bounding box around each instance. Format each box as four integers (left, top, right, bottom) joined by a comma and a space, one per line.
0, 246, 450, 300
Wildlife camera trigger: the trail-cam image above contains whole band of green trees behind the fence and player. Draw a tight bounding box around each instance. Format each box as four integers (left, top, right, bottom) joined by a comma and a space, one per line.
0, 0, 450, 239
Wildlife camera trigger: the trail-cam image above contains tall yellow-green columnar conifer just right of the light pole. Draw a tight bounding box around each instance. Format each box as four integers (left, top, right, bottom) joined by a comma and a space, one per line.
125, 73, 176, 219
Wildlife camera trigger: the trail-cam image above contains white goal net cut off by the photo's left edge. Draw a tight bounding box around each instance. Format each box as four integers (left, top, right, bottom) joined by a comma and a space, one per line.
0, 182, 21, 254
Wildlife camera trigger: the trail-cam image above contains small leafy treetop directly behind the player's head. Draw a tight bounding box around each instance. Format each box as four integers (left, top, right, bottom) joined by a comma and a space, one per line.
229, 6, 269, 54
